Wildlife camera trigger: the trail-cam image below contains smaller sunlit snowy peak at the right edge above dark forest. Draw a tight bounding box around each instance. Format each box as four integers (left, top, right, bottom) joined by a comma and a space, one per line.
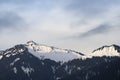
86, 44, 120, 57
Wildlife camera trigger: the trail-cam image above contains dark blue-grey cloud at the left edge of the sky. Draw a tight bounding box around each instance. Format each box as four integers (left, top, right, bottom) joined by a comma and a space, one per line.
0, 11, 25, 30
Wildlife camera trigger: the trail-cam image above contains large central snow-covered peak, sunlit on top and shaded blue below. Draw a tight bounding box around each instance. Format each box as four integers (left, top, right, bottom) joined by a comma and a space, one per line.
25, 41, 83, 62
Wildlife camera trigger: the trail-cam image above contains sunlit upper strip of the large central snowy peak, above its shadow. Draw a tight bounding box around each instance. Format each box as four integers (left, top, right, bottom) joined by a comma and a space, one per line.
25, 41, 82, 55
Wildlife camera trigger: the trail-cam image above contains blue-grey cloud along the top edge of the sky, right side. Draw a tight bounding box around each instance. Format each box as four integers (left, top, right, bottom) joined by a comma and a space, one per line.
65, 0, 120, 17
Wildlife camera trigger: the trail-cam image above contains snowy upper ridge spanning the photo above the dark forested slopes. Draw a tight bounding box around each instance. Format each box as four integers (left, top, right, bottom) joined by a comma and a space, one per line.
0, 41, 120, 62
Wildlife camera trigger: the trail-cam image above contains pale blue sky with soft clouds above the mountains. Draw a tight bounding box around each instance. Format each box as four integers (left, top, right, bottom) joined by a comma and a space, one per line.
0, 0, 120, 54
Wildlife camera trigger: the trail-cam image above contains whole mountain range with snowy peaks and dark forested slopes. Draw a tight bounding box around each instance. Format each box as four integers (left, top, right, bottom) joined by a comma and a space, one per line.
0, 41, 120, 80
